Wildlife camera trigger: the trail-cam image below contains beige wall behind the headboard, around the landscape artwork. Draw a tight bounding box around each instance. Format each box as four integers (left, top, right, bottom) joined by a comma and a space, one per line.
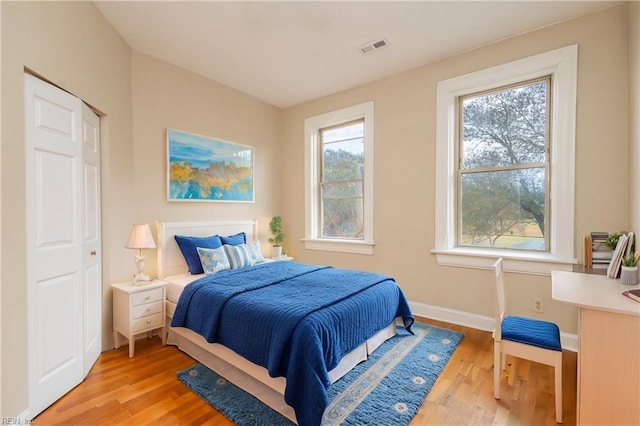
131, 52, 282, 273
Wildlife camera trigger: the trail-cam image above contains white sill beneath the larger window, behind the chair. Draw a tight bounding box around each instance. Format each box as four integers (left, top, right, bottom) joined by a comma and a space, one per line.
431, 248, 578, 275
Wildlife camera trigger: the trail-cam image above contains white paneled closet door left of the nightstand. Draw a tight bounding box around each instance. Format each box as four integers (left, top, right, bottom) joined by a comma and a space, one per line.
25, 74, 102, 417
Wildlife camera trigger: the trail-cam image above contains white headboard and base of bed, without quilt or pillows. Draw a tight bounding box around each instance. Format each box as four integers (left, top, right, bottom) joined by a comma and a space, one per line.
156, 220, 396, 423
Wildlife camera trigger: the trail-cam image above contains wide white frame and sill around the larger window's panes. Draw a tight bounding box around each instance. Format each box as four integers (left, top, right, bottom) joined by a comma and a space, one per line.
431, 45, 578, 275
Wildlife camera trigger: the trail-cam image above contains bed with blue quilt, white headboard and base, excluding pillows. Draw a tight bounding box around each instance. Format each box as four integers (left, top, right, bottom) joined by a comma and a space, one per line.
156, 220, 413, 425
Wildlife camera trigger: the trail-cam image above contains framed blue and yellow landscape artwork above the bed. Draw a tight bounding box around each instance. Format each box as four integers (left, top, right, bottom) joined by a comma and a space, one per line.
167, 129, 254, 203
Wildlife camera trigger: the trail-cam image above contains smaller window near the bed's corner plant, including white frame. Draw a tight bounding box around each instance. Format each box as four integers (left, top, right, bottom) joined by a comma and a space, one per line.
304, 102, 373, 254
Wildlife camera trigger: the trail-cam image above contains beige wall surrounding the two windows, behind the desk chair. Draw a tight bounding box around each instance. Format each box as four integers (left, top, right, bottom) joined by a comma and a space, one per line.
282, 6, 628, 333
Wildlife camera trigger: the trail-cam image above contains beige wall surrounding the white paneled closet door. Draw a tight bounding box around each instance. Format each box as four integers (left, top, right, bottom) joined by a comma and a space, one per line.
1, 1, 135, 416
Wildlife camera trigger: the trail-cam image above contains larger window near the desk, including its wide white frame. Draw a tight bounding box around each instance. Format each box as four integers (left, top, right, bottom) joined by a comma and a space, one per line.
432, 46, 577, 274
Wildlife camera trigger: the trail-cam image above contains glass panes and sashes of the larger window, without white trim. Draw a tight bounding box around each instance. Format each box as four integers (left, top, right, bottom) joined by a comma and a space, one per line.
457, 77, 551, 251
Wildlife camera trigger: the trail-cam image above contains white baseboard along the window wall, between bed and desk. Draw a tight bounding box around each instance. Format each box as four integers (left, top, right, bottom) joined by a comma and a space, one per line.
409, 301, 578, 352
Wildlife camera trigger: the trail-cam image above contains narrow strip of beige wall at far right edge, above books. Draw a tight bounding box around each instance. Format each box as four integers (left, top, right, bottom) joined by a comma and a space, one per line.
627, 1, 640, 233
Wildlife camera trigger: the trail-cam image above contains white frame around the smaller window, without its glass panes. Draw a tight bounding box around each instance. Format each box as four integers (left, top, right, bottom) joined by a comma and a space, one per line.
302, 101, 375, 255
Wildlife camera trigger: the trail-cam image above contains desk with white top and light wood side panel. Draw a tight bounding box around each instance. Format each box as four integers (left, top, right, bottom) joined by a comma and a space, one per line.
551, 271, 640, 425
